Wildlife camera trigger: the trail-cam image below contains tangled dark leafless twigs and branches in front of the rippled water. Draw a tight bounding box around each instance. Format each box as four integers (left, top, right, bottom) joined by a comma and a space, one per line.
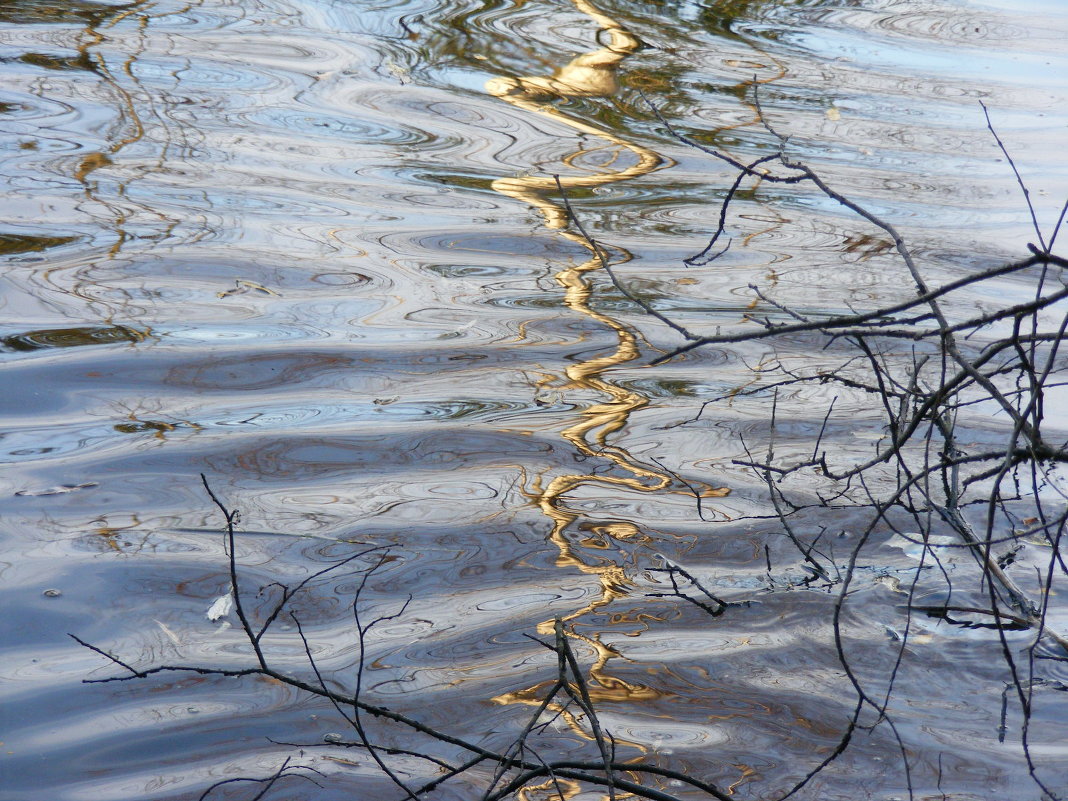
72, 87, 1068, 801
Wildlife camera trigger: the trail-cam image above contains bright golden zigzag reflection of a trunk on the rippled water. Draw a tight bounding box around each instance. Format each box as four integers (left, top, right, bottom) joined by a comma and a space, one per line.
486, 0, 729, 777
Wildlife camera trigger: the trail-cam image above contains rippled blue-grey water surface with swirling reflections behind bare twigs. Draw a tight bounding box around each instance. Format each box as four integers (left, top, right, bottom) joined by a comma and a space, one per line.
0, 0, 1068, 801
